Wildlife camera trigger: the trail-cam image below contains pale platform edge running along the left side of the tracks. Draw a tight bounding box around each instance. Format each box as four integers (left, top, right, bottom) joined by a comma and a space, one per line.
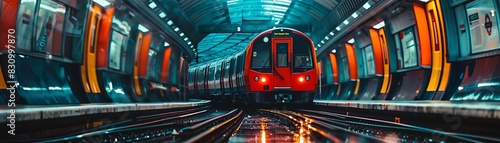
0, 100, 210, 123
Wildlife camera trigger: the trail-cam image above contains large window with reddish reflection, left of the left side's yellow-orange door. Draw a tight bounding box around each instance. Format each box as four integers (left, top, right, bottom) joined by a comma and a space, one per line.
35, 0, 66, 56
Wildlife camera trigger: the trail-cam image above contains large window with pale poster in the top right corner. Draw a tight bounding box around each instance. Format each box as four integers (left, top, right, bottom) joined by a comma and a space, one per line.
466, 0, 500, 54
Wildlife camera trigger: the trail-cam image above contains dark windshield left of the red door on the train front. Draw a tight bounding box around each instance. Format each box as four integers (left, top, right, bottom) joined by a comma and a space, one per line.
250, 44, 271, 72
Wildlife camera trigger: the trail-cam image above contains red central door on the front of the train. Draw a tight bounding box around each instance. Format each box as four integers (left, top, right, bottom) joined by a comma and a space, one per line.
272, 38, 293, 90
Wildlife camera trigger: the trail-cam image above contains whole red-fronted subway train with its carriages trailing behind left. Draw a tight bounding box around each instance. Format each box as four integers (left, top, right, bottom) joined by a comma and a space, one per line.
188, 28, 318, 104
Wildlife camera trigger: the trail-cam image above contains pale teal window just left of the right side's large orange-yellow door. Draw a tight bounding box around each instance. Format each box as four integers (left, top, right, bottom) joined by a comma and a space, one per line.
394, 27, 418, 69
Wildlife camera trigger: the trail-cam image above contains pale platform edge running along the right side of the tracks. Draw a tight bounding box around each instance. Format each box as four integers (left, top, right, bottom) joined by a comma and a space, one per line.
314, 100, 500, 119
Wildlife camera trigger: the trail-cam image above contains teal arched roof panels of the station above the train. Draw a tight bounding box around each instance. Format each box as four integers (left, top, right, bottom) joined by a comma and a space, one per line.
171, 0, 367, 66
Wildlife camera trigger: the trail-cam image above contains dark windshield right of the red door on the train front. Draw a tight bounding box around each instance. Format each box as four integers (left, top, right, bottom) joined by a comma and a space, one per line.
293, 42, 314, 72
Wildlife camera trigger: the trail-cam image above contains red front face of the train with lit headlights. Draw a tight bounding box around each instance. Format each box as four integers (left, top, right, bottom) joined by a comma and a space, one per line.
245, 28, 318, 104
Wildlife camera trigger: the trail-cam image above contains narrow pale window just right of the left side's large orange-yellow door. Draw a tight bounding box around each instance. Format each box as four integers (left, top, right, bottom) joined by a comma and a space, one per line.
108, 30, 126, 70
